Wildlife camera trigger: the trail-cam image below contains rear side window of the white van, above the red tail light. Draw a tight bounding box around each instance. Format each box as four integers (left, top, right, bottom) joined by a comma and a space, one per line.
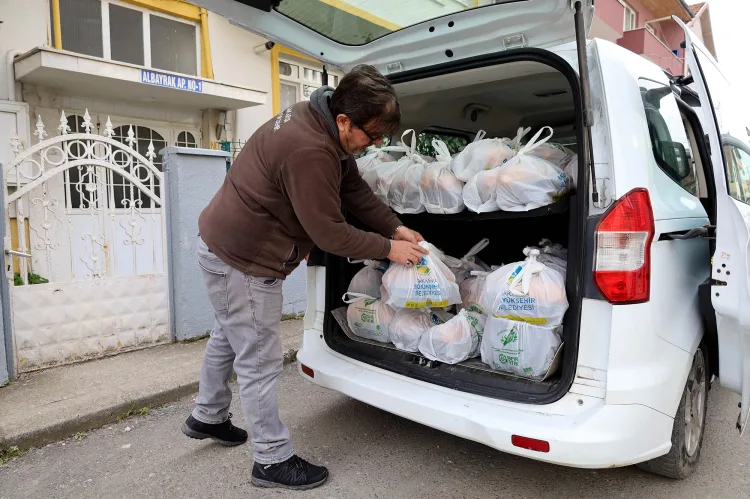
639, 79, 700, 196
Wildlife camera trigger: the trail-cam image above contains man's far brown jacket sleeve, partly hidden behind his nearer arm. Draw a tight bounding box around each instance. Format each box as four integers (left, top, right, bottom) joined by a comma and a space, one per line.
341, 161, 401, 237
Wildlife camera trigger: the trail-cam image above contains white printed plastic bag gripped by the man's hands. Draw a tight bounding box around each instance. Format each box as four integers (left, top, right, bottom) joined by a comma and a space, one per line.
383, 241, 461, 309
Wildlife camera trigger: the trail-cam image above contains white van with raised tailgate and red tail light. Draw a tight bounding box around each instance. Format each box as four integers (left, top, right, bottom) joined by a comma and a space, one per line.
193, 0, 750, 478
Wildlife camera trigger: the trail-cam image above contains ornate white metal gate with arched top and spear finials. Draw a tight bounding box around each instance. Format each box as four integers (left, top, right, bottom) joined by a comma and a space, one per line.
3, 111, 170, 372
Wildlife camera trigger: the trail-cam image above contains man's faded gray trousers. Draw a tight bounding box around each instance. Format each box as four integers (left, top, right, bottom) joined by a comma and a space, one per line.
193, 238, 294, 464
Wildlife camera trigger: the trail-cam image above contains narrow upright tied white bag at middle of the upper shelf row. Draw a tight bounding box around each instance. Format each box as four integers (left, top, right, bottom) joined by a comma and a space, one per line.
419, 140, 464, 215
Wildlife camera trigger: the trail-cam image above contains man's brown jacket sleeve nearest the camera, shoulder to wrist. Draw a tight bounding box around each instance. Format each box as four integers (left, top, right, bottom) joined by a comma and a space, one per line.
279, 149, 391, 259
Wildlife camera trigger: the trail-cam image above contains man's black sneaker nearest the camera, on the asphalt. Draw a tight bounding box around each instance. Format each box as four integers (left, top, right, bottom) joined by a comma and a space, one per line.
250, 455, 328, 490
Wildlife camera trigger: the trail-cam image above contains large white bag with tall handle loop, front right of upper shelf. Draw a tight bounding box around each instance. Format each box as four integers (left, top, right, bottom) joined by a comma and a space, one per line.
496, 127, 570, 211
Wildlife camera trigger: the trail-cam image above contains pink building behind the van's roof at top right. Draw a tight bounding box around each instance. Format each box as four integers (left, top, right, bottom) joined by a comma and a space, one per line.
590, 0, 716, 75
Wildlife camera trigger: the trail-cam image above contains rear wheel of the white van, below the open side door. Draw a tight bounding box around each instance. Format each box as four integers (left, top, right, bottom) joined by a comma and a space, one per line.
638, 345, 708, 479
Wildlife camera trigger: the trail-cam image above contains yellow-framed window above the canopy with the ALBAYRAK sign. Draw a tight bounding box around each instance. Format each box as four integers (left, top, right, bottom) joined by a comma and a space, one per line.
50, 0, 213, 78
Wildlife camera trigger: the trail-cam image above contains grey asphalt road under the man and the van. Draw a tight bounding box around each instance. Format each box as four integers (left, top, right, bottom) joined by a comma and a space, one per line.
0, 368, 750, 499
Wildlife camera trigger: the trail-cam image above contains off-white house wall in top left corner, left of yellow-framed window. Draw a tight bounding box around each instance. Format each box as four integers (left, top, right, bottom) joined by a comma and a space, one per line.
0, 0, 49, 100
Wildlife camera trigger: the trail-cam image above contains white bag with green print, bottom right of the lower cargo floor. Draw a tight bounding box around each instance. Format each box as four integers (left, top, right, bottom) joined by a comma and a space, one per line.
481, 317, 562, 378
